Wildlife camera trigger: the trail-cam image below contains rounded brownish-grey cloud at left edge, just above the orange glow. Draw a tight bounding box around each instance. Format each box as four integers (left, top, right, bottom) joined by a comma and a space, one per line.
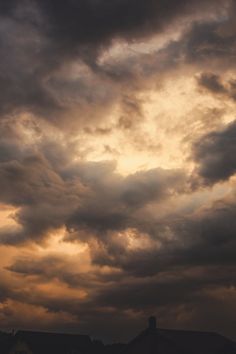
0, 151, 81, 244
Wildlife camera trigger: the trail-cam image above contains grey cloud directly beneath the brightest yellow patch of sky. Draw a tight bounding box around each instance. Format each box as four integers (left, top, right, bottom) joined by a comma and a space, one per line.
68, 165, 185, 238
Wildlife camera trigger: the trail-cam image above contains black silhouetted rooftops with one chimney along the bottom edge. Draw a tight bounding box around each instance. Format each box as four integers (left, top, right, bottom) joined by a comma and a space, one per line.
0, 316, 236, 354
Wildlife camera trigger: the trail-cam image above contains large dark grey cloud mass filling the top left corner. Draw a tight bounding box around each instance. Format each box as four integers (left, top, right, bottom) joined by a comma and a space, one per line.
0, 0, 228, 124
